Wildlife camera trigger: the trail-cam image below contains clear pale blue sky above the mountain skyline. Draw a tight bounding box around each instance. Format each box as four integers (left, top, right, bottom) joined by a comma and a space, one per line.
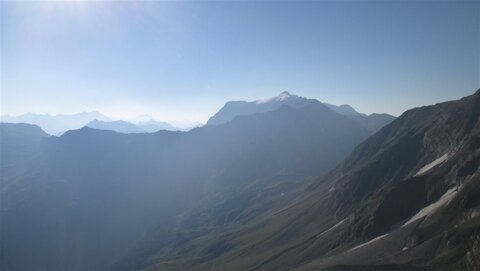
0, 1, 480, 122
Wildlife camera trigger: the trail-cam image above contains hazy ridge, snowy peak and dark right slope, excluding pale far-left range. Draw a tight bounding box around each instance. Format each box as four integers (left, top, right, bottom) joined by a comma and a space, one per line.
0, 90, 480, 270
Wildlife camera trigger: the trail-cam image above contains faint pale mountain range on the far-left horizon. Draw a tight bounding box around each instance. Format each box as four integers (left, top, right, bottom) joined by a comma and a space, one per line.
1, 111, 191, 135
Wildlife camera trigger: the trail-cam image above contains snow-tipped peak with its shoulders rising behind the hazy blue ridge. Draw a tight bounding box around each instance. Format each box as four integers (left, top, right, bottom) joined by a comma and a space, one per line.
207, 91, 395, 132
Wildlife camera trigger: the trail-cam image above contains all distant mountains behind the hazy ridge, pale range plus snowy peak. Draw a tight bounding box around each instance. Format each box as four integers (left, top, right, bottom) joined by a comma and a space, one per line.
0, 91, 395, 136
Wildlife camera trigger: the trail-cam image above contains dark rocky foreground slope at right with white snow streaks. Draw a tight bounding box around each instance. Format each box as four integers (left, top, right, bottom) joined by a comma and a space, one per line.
141, 91, 480, 270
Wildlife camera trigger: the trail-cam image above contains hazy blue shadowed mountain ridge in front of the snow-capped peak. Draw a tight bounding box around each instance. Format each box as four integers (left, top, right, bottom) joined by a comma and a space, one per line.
0, 101, 370, 270
